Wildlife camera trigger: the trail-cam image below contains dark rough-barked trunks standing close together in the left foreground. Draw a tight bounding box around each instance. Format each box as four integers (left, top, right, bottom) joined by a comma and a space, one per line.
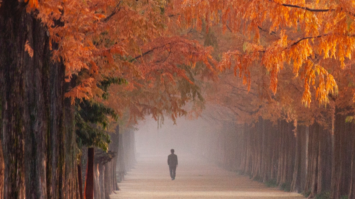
0, 0, 76, 199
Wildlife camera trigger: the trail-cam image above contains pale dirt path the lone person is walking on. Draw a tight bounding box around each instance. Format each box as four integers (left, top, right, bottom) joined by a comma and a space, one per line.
110, 154, 304, 199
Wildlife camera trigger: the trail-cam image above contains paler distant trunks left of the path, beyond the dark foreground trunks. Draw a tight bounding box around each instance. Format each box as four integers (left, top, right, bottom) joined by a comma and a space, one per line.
81, 127, 135, 199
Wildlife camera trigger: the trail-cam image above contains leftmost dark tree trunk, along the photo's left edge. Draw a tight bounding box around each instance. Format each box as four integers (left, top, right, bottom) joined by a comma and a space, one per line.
0, 1, 27, 199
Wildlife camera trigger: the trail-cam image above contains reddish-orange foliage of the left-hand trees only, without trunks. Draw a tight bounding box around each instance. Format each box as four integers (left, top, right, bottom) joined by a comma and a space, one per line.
25, 0, 217, 120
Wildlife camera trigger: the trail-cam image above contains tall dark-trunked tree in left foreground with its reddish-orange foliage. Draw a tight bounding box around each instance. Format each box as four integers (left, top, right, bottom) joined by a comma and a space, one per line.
0, 0, 217, 198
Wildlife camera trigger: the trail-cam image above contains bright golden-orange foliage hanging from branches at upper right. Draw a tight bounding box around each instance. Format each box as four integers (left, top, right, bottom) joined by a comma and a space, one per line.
175, 0, 355, 106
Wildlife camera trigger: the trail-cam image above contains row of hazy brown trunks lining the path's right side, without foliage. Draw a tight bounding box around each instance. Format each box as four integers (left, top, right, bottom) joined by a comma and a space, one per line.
188, 114, 355, 198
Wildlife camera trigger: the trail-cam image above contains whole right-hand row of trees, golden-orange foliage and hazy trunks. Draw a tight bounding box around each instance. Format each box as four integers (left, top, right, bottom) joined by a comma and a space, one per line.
185, 0, 355, 199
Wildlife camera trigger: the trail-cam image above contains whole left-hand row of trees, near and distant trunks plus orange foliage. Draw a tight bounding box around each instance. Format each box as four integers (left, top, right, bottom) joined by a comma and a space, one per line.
0, 0, 215, 199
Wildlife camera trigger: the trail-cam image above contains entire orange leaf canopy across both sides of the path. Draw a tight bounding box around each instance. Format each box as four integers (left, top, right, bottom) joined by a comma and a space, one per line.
25, 0, 355, 124
